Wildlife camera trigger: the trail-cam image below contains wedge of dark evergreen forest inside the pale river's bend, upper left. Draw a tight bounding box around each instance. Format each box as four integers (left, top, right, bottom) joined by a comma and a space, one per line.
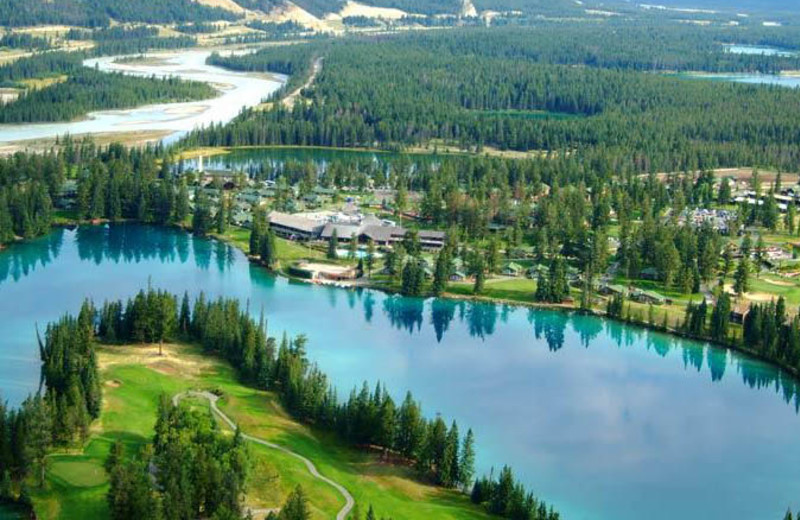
0, 68, 216, 123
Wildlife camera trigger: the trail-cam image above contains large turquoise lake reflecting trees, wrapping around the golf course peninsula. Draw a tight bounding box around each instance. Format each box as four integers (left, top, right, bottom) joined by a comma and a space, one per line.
0, 226, 800, 520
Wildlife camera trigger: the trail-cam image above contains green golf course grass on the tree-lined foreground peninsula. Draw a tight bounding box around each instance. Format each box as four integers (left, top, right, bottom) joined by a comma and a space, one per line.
32, 345, 488, 520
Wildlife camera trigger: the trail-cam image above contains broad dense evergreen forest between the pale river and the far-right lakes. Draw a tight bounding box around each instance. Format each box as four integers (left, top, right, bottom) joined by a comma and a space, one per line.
185, 31, 800, 172
